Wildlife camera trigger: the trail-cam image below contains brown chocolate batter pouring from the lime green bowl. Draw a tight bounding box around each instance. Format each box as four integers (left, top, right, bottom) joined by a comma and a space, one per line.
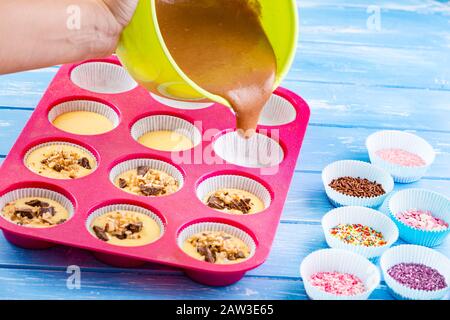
156, 0, 277, 136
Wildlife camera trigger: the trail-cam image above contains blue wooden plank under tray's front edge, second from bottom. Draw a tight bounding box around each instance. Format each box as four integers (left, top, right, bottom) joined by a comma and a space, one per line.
0, 223, 450, 278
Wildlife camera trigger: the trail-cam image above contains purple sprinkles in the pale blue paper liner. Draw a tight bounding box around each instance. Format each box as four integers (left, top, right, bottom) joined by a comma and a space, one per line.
388, 263, 447, 291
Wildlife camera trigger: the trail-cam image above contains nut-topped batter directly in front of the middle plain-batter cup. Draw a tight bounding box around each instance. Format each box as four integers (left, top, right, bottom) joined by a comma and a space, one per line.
114, 166, 179, 197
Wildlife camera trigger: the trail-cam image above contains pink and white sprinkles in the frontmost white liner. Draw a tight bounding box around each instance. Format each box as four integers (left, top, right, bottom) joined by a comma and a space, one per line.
309, 272, 366, 296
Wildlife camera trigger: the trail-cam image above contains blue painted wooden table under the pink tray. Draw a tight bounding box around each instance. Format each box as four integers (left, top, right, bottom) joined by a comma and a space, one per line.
0, 0, 450, 299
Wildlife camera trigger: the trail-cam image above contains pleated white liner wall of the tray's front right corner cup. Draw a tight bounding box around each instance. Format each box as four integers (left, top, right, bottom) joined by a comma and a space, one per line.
177, 222, 256, 262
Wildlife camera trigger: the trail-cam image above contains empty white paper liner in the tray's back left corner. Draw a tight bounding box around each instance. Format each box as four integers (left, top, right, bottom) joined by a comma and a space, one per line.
70, 62, 137, 94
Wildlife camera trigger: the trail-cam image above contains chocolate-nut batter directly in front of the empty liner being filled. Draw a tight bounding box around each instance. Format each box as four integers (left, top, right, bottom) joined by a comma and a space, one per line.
204, 189, 264, 215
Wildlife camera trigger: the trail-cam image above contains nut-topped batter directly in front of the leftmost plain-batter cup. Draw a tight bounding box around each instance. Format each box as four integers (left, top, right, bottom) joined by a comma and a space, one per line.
25, 144, 97, 179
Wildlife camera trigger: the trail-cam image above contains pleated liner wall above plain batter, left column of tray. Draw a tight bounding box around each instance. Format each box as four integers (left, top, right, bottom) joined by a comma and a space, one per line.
48, 100, 119, 128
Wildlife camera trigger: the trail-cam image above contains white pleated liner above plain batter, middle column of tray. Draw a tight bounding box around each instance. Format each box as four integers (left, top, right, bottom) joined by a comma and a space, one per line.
131, 115, 202, 147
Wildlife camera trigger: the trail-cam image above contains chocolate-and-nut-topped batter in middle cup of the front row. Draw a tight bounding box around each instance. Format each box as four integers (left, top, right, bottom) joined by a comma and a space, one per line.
91, 211, 161, 247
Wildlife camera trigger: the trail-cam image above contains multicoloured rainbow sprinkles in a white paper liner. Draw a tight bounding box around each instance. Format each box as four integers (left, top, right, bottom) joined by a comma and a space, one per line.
330, 224, 387, 247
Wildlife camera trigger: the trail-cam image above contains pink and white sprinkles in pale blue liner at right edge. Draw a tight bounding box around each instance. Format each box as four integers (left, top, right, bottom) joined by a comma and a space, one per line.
397, 209, 448, 231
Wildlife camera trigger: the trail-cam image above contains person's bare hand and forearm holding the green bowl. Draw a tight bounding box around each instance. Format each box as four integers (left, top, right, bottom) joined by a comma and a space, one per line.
0, 0, 139, 74
